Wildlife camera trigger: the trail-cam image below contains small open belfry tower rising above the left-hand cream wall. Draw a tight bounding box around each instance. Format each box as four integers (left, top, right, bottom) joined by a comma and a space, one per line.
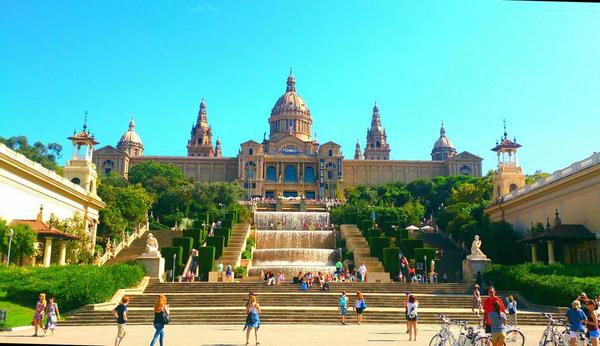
63, 111, 98, 196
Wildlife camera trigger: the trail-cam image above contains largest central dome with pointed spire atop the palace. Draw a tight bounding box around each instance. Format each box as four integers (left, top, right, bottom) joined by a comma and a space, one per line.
269, 70, 312, 141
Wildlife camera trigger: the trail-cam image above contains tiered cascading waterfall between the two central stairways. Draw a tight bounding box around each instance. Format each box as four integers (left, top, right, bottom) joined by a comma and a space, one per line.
248, 212, 339, 280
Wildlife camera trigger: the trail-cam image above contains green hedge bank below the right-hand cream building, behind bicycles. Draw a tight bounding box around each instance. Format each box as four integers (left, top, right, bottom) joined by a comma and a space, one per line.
484, 263, 600, 307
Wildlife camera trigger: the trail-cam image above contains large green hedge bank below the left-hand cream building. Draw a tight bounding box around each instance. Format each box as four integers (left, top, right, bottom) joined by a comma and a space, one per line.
0, 262, 144, 313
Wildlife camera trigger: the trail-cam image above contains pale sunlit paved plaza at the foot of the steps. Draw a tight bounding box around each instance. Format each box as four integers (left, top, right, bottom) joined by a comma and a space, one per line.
0, 322, 544, 346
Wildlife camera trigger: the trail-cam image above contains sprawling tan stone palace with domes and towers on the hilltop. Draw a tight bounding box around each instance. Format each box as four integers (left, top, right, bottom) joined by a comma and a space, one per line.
94, 71, 482, 199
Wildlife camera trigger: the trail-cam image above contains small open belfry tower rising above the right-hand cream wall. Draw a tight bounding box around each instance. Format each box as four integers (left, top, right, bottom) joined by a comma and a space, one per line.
492, 121, 525, 200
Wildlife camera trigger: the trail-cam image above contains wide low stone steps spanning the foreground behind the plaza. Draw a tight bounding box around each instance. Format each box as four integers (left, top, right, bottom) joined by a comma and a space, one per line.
62, 282, 546, 325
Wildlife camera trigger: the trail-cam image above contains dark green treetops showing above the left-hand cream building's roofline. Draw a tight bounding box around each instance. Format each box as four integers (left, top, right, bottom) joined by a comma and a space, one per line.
0, 136, 62, 173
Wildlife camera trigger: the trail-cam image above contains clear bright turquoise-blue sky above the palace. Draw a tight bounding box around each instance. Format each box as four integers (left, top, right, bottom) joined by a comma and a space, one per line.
0, 0, 600, 173
